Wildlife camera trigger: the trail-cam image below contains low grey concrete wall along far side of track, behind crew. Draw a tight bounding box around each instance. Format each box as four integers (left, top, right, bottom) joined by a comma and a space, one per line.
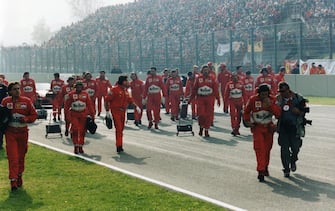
6, 73, 335, 97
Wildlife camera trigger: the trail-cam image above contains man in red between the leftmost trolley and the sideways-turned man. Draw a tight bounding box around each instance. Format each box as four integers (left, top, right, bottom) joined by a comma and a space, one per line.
64, 81, 95, 154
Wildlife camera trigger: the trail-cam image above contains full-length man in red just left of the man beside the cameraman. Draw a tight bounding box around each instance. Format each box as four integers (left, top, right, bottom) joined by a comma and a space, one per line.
224, 72, 244, 136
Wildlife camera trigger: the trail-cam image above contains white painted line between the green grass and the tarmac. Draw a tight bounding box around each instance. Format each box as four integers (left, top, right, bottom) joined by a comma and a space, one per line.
29, 140, 245, 211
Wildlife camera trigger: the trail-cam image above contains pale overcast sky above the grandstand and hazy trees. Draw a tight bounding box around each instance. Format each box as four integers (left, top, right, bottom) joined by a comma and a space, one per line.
0, 0, 134, 46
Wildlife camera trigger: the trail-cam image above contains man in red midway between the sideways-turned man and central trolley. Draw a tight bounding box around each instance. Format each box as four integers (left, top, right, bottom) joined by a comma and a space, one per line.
143, 67, 166, 129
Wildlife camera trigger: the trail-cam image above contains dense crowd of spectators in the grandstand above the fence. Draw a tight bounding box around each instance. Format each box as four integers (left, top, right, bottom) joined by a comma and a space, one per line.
47, 0, 335, 46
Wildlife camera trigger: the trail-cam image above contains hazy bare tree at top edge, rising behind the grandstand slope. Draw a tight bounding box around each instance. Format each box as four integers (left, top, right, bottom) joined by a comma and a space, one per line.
67, 0, 103, 19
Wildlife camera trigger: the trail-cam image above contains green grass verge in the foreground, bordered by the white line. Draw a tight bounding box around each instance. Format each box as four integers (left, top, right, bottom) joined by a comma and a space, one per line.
0, 144, 227, 211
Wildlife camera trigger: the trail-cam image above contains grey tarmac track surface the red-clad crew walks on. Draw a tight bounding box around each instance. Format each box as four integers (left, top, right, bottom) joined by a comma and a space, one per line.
29, 105, 335, 210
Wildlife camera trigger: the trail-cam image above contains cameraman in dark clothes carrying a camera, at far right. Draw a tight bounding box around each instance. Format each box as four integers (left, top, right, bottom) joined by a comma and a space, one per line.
277, 82, 308, 177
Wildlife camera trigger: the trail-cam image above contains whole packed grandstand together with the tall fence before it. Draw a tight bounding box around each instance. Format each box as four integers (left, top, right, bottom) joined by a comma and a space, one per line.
0, 0, 335, 73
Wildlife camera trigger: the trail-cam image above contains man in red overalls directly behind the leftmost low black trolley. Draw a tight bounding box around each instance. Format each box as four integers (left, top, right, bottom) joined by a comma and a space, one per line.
50, 73, 64, 121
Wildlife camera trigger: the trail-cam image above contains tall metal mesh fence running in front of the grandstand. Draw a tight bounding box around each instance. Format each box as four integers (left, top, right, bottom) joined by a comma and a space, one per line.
0, 20, 335, 74
